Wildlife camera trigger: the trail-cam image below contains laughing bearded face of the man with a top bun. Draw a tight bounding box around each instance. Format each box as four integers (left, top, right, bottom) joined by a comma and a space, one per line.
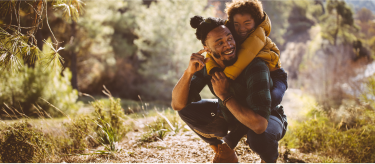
205, 25, 237, 67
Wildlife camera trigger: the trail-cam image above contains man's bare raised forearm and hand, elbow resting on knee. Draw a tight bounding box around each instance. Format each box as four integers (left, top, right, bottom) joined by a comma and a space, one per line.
171, 50, 207, 111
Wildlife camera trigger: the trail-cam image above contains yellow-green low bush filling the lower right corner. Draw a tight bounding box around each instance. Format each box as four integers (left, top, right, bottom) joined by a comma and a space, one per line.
285, 107, 375, 163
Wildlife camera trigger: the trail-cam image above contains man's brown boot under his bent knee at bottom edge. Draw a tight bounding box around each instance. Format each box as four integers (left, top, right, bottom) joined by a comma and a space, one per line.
210, 143, 238, 164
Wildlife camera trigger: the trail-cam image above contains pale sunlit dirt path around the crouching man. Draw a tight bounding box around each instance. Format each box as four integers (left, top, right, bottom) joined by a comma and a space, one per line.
61, 89, 319, 164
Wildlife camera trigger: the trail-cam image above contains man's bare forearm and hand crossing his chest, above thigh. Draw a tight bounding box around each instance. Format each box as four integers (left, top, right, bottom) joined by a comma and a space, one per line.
211, 72, 268, 134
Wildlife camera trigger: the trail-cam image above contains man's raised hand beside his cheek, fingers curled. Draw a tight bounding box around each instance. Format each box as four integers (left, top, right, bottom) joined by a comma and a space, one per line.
186, 49, 209, 75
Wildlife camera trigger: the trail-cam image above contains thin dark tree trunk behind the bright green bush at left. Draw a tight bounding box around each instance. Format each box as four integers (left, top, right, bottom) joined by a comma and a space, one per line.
70, 21, 78, 90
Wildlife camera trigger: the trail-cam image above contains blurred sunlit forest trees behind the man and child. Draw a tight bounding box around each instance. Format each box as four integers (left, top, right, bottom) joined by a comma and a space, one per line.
0, 0, 375, 161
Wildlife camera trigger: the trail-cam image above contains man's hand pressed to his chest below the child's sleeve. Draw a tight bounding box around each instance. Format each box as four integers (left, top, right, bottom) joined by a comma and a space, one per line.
211, 72, 230, 100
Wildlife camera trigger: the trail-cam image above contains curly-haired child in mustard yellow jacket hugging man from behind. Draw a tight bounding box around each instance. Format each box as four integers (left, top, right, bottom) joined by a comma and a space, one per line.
206, 0, 288, 109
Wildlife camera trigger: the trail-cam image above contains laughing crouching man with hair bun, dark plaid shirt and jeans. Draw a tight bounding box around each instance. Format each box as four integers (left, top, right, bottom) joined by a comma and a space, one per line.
171, 16, 286, 163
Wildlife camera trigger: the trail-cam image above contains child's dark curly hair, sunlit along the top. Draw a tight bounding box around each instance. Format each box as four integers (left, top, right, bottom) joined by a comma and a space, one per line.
225, 0, 264, 26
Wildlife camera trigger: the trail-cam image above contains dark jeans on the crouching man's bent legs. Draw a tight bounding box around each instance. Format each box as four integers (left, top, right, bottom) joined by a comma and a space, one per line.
178, 99, 287, 163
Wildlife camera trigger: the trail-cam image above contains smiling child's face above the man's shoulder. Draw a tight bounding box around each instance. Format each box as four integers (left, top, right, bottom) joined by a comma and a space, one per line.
233, 14, 255, 39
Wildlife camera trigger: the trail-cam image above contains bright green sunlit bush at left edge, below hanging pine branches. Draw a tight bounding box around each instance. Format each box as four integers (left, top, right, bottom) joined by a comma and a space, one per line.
0, 64, 78, 117
